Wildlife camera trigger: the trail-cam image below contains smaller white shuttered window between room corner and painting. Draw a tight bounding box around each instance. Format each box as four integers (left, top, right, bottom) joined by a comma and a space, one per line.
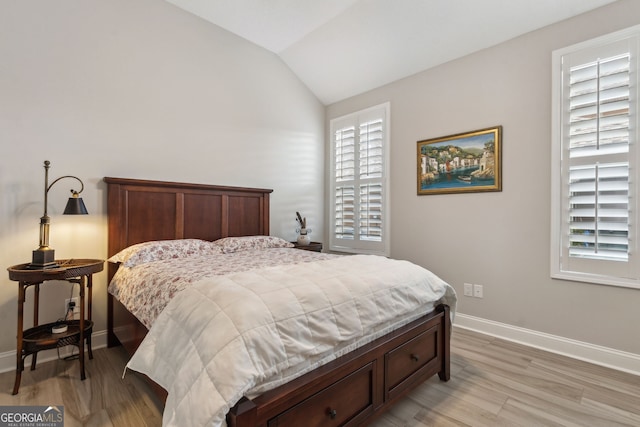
329, 103, 389, 256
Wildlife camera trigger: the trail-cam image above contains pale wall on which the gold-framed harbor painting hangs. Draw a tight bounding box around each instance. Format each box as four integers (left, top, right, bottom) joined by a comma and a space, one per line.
327, 0, 640, 358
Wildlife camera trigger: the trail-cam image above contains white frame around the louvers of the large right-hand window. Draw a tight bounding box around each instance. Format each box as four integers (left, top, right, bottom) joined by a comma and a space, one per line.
551, 25, 640, 289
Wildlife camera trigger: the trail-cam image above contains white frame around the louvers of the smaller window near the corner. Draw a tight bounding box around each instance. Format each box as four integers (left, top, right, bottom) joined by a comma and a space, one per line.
328, 102, 391, 257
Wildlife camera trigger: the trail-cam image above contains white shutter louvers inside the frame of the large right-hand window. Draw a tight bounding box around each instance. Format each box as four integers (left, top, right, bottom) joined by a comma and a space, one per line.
568, 54, 630, 261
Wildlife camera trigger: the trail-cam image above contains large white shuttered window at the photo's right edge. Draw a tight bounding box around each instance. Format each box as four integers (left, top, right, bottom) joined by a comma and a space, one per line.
551, 26, 640, 288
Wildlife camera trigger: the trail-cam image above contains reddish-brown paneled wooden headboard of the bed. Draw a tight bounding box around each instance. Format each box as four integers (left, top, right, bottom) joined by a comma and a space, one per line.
104, 177, 273, 256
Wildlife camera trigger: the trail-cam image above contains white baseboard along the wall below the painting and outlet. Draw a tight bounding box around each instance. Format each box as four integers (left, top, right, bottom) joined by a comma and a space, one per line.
455, 313, 640, 376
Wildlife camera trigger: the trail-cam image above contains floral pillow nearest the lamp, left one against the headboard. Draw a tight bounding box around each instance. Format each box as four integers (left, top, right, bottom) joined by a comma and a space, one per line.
108, 239, 222, 267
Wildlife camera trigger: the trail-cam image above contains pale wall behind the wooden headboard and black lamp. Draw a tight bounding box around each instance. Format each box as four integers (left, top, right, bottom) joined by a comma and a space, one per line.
0, 0, 324, 354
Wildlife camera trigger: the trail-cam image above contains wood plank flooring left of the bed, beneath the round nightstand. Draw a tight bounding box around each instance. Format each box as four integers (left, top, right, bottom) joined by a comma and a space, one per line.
0, 347, 162, 427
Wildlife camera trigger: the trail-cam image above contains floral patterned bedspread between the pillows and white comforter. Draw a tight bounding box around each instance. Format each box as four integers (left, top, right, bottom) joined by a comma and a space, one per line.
108, 248, 339, 328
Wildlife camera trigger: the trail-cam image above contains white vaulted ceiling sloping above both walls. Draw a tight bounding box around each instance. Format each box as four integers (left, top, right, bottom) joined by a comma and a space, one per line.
167, 0, 615, 105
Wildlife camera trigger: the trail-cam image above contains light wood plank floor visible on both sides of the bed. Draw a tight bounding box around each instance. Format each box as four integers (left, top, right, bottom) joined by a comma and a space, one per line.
0, 328, 640, 427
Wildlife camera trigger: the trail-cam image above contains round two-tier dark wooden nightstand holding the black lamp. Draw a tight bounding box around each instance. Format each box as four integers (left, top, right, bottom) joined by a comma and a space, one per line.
7, 259, 104, 394
